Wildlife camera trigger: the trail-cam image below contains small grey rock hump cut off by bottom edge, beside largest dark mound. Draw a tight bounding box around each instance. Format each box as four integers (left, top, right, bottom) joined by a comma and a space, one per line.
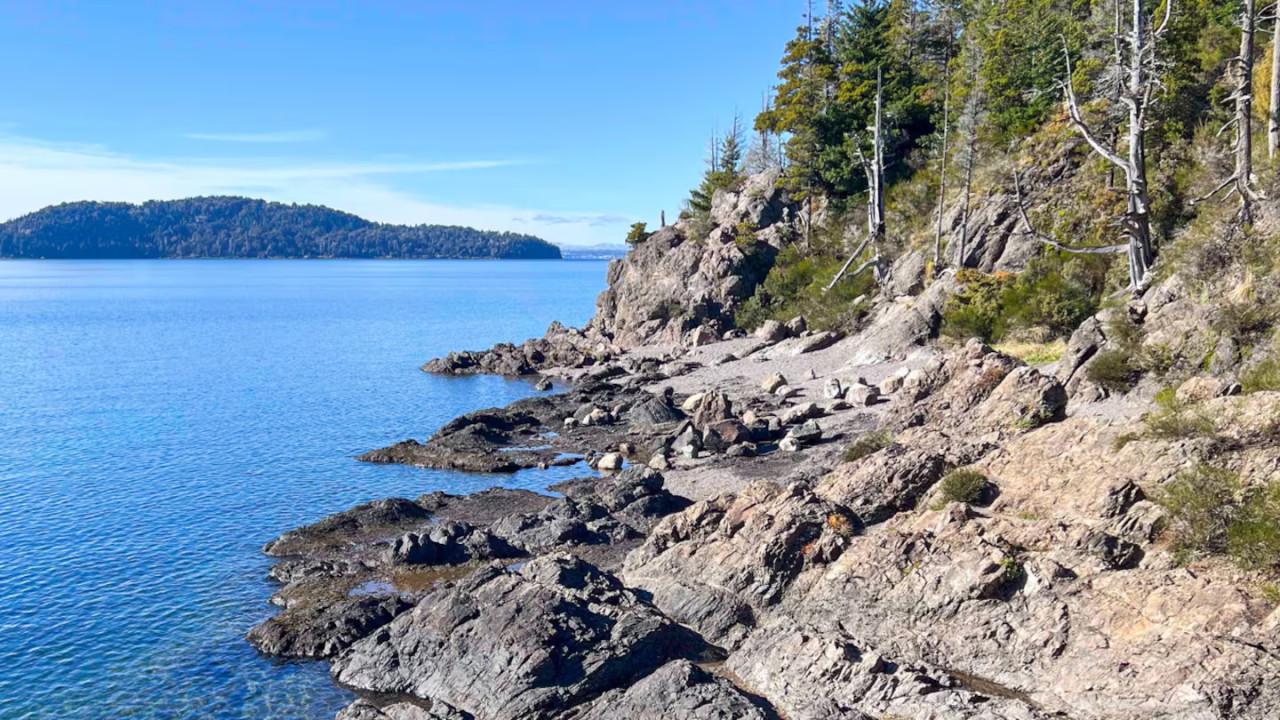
577, 660, 778, 720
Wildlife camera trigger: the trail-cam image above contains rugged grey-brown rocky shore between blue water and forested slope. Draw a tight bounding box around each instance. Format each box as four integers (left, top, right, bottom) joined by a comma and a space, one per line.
248, 170, 1280, 720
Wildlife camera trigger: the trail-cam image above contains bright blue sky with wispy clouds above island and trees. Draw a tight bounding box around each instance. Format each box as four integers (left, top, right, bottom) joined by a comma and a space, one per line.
0, 0, 805, 245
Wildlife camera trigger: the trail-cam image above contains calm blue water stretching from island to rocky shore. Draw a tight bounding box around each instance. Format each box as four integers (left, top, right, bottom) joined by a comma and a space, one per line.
0, 260, 604, 720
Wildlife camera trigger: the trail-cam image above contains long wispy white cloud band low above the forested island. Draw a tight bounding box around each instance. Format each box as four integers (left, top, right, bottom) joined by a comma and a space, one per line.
0, 135, 621, 245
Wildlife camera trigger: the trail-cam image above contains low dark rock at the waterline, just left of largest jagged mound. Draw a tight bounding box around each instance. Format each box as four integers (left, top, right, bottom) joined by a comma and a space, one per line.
248, 594, 413, 660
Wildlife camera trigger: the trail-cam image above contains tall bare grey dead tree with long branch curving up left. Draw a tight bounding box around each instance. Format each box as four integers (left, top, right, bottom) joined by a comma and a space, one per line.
1062, 0, 1172, 291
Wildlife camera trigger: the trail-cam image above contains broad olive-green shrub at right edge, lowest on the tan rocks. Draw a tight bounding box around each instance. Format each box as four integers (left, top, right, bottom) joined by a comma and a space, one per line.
1157, 464, 1280, 570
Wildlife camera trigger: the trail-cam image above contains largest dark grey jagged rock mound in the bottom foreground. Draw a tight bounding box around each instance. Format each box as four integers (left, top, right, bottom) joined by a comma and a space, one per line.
333, 555, 698, 720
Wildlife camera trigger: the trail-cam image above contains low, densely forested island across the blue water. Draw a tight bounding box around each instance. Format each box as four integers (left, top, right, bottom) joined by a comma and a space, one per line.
0, 197, 561, 260
